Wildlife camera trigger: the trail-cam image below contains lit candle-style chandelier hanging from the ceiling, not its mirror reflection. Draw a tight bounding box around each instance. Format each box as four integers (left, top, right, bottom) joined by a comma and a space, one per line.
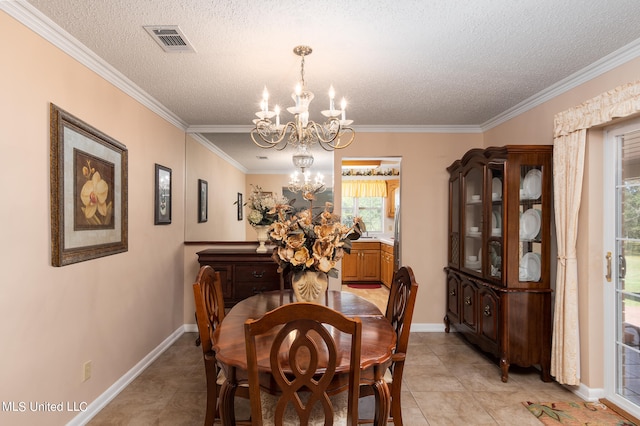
251, 46, 355, 155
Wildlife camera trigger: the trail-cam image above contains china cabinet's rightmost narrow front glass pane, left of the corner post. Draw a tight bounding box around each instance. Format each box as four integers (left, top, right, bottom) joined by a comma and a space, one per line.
486, 163, 504, 281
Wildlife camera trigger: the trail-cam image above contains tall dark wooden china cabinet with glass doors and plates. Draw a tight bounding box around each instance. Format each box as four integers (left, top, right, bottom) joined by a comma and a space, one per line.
444, 145, 553, 382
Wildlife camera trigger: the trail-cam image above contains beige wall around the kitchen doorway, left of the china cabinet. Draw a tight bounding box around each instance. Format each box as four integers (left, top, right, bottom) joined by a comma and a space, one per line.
334, 133, 482, 329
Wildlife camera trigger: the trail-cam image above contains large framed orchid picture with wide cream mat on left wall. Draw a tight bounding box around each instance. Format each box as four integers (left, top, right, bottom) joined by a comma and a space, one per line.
50, 104, 128, 266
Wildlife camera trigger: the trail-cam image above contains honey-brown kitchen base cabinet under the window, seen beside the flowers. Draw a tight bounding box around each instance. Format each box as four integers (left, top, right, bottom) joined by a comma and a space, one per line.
342, 241, 380, 283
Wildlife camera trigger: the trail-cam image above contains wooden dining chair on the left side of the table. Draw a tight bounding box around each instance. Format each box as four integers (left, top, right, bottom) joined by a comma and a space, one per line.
193, 265, 250, 426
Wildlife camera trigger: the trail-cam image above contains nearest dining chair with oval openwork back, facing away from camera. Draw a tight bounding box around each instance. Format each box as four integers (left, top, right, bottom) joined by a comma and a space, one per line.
245, 302, 362, 426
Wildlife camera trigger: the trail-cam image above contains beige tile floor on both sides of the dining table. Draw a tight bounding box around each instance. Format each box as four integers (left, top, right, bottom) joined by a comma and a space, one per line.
89, 286, 580, 426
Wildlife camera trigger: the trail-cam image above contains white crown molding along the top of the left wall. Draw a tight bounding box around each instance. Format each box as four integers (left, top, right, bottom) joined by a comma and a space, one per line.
0, 0, 187, 131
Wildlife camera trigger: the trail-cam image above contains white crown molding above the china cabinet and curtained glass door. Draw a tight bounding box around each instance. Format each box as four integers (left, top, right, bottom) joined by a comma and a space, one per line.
480, 39, 640, 132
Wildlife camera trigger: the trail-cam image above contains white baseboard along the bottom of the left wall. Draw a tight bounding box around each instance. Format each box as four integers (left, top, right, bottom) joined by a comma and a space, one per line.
67, 324, 186, 426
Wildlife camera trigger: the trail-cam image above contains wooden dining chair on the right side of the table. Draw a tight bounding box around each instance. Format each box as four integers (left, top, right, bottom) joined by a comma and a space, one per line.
359, 266, 418, 426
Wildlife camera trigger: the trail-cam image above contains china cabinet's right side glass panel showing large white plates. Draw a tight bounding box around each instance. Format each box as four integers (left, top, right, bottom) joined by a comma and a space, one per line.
518, 165, 543, 282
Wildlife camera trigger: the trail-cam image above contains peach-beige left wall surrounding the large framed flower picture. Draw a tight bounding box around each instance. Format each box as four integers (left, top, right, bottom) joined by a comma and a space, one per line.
0, 12, 185, 425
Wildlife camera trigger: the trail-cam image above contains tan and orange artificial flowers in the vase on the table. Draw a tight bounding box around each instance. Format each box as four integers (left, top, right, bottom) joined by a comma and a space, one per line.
269, 203, 365, 277
